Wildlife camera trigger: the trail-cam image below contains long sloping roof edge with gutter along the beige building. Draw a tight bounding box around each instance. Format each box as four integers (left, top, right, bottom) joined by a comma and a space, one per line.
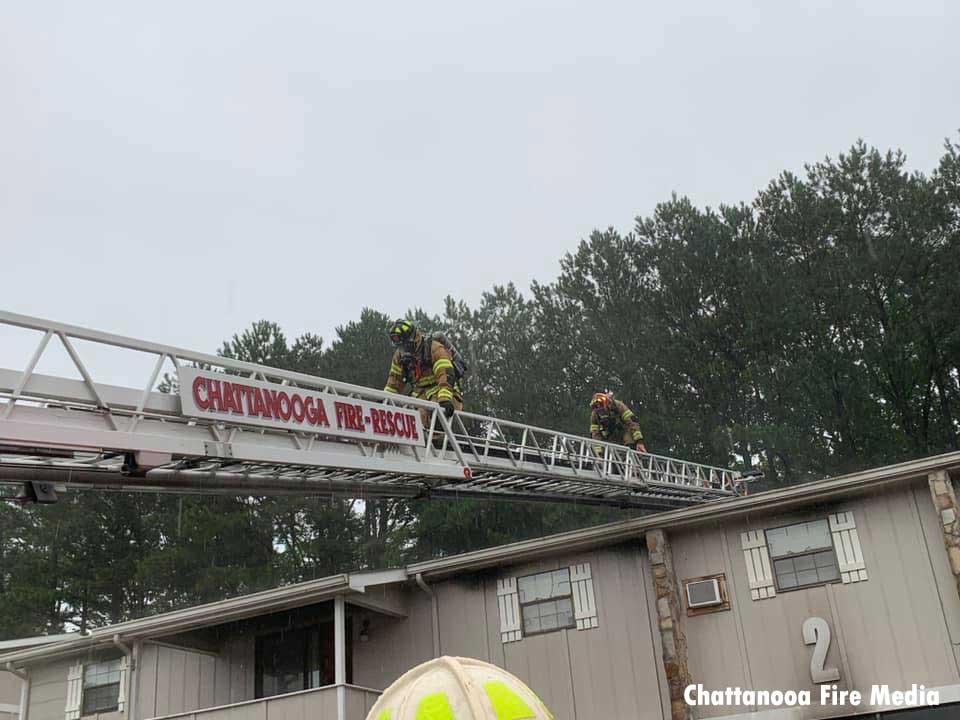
0, 452, 960, 667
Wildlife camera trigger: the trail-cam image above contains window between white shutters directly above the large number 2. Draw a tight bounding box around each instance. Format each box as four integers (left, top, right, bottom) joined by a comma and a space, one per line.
766, 520, 840, 592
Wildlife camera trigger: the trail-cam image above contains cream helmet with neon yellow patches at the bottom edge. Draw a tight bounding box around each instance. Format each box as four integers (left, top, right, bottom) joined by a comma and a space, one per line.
367, 657, 553, 720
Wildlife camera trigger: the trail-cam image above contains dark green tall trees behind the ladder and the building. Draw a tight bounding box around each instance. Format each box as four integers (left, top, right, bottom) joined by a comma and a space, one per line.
0, 142, 960, 638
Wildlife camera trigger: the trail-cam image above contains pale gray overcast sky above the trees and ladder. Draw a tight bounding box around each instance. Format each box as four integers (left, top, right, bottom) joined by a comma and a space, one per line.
0, 0, 960, 388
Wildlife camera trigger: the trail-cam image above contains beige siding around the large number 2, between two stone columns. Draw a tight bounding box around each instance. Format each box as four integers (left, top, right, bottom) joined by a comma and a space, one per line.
672, 480, 960, 717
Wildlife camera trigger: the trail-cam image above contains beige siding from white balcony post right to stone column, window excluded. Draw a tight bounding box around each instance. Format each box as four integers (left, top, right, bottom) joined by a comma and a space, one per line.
354, 541, 663, 720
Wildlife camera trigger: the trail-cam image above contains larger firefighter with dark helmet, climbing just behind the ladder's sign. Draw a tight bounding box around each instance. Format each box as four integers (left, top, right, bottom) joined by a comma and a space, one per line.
383, 319, 463, 427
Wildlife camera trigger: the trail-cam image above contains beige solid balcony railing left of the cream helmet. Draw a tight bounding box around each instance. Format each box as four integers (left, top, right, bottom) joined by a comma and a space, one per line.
150, 685, 380, 720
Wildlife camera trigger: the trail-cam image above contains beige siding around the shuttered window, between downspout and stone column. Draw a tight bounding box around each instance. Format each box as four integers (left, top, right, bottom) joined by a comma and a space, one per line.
448, 543, 663, 720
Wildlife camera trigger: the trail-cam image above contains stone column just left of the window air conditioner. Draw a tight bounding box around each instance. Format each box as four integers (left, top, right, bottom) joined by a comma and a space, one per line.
646, 530, 694, 720
